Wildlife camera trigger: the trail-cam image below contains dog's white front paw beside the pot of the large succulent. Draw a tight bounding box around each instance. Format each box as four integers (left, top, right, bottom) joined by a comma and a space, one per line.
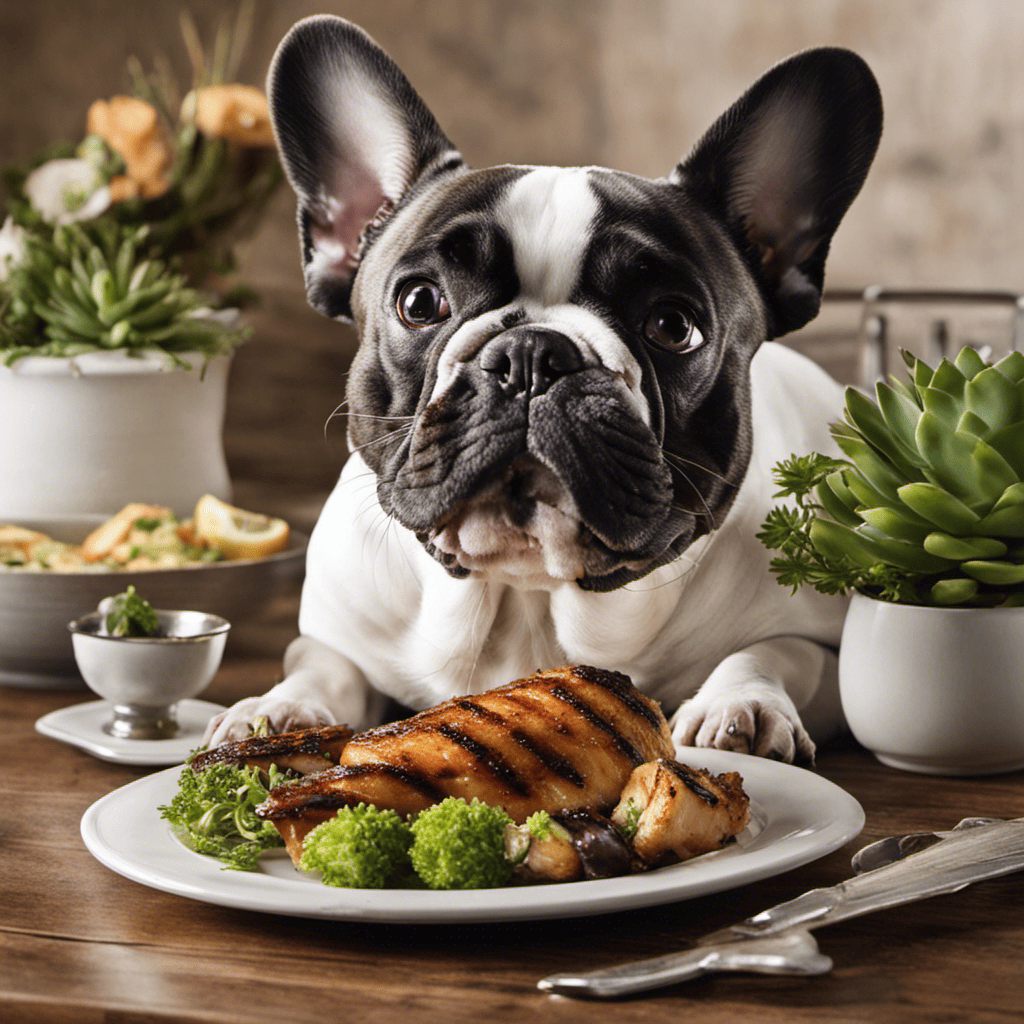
672, 685, 814, 764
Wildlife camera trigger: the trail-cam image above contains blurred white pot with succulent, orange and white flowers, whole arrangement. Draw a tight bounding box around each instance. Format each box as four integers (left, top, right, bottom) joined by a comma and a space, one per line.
0, 5, 282, 518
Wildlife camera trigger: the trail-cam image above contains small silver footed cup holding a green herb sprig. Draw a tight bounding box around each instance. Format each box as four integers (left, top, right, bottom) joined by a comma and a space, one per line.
68, 608, 230, 739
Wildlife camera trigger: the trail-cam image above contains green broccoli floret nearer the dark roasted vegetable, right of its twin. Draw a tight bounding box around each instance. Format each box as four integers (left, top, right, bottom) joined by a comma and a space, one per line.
410, 797, 512, 889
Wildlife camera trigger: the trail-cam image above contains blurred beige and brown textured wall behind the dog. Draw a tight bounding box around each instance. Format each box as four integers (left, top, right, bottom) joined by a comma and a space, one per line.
0, 0, 1024, 490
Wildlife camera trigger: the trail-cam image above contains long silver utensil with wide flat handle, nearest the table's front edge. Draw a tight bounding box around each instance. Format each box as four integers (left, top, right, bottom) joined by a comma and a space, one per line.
538, 818, 1024, 999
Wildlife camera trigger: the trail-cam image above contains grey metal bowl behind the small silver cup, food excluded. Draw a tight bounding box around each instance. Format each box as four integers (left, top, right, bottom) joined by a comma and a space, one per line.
0, 515, 308, 688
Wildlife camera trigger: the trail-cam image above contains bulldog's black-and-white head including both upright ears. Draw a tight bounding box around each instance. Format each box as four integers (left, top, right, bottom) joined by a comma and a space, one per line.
268, 17, 881, 590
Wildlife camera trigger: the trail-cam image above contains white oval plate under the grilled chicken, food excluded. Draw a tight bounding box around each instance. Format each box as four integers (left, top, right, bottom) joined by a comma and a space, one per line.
82, 748, 864, 924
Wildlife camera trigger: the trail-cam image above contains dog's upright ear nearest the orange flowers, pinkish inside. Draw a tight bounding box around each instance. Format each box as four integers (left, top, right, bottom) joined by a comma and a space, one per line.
266, 14, 462, 318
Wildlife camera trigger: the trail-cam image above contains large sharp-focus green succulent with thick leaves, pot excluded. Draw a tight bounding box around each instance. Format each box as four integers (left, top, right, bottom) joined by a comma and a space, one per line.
758, 347, 1024, 606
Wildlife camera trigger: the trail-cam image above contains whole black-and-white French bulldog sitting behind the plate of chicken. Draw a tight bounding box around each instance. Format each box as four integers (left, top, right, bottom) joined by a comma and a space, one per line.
207, 15, 882, 761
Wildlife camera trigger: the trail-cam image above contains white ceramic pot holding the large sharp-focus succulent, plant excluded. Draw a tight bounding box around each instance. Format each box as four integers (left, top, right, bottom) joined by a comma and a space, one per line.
839, 594, 1024, 775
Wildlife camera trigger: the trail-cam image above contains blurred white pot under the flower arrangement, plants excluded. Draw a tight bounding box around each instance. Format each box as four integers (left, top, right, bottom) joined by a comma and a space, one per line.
0, 351, 230, 521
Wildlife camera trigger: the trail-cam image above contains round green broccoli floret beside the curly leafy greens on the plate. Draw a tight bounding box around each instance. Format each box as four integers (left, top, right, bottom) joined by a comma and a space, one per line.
299, 804, 413, 889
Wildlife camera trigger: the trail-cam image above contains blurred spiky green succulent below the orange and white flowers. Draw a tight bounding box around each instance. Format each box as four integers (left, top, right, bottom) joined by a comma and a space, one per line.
0, 219, 245, 366
